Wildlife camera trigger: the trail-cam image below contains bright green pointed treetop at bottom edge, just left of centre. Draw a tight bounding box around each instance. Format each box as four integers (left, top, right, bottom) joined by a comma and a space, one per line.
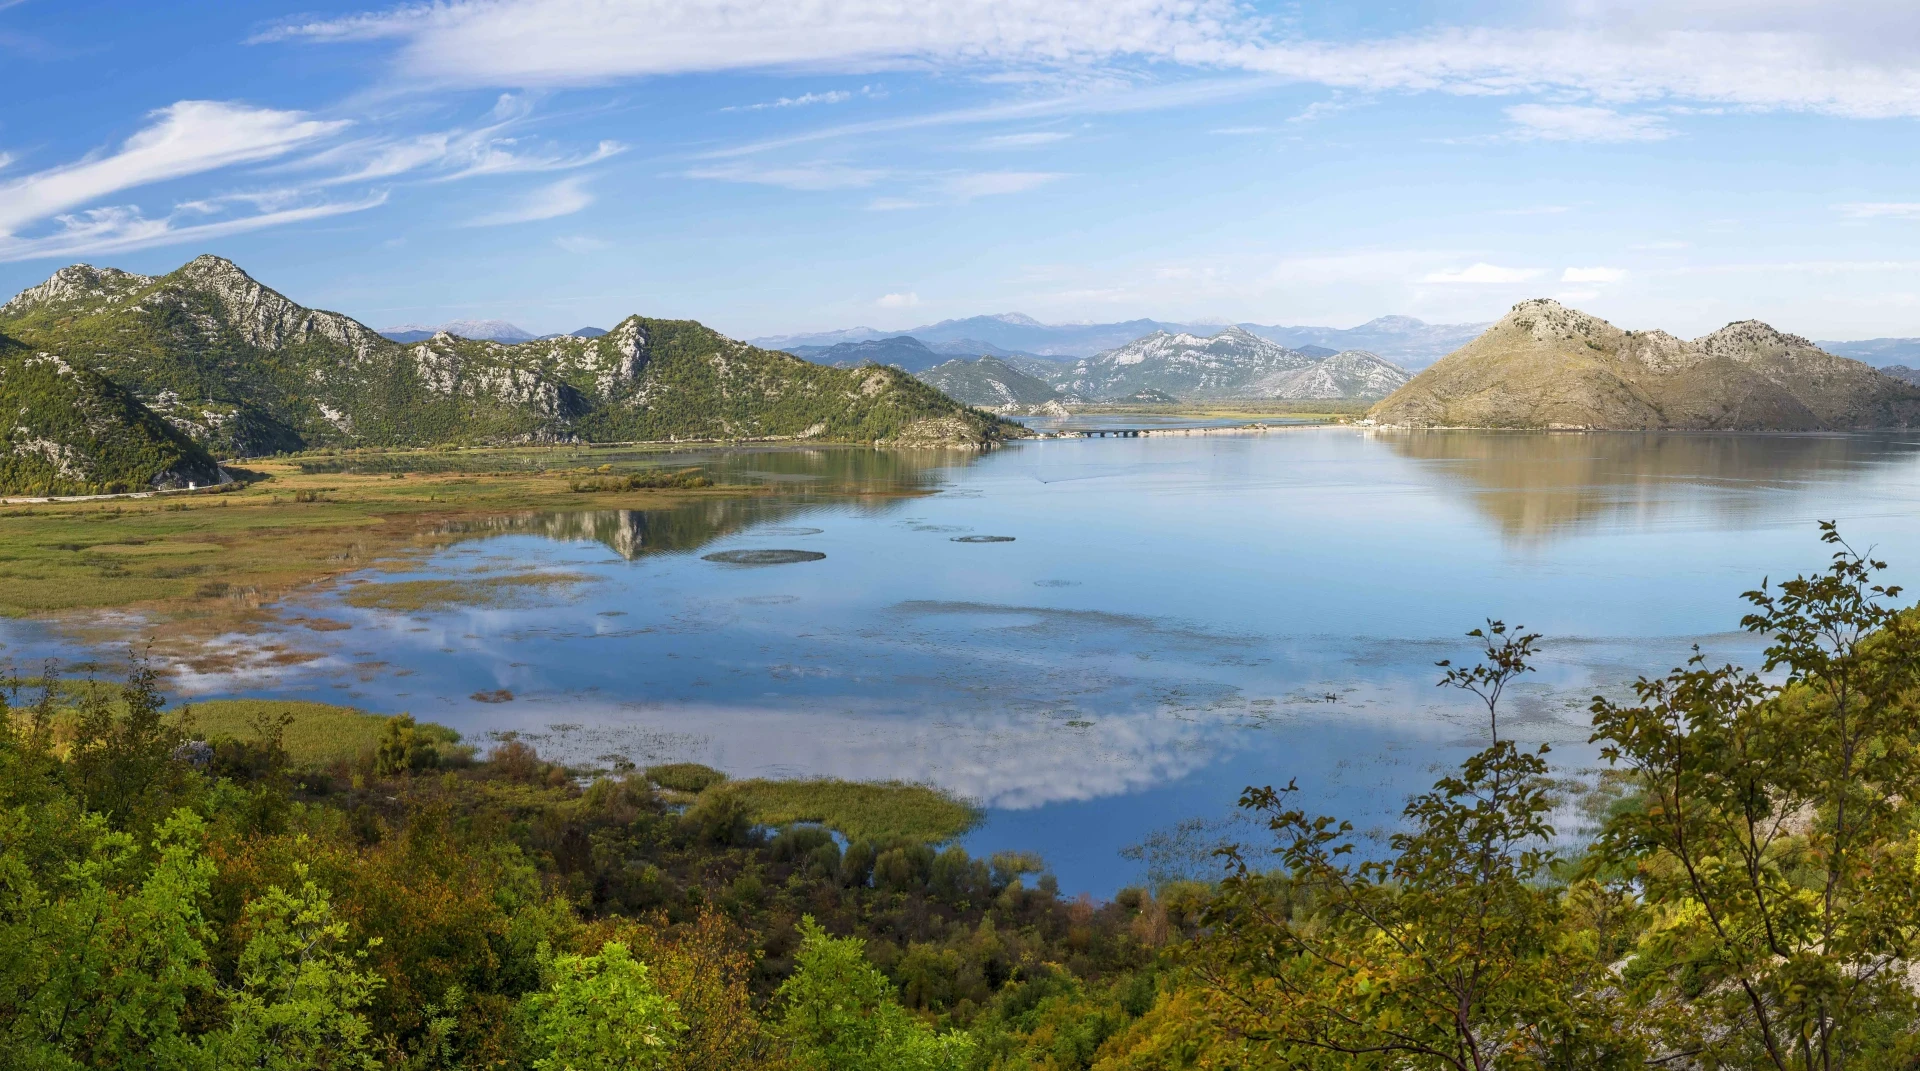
778, 916, 973, 1071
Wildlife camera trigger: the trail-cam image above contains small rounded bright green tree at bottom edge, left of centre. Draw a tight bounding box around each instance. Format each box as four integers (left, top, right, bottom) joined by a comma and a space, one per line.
520, 940, 685, 1071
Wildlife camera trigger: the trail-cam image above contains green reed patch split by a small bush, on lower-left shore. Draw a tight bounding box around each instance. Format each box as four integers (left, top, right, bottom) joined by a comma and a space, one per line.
173, 699, 470, 770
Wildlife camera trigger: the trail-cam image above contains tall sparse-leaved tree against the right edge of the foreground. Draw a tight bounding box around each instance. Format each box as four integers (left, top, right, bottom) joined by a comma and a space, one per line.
1594, 522, 1920, 1071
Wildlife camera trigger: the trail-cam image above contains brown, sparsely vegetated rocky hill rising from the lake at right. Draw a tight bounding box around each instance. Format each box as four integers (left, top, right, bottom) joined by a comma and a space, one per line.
1369, 299, 1920, 432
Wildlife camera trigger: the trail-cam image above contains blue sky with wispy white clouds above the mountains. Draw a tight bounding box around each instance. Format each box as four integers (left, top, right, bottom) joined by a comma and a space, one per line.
0, 0, 1920, 338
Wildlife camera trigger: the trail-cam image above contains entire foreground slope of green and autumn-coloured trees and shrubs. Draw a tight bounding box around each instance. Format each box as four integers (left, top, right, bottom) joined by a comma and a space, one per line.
0, 526, 1920, 1071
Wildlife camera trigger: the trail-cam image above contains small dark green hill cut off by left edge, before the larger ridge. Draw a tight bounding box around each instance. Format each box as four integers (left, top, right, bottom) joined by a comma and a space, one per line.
0, 336, 219, 495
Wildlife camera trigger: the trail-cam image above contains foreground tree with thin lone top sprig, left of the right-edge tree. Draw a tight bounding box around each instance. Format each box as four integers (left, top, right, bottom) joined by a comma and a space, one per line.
1196, 622, 1642, 1071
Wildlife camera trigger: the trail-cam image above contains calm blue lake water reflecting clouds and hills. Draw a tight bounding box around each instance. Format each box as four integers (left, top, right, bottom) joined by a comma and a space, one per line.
15, 428, 1920, 894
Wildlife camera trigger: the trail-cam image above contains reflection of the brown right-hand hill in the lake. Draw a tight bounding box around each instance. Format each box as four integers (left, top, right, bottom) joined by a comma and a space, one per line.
1373, 430, 1920, 543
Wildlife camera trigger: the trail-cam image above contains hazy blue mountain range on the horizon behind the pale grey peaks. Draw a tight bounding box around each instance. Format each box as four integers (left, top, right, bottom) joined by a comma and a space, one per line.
753, 313, 1486, 369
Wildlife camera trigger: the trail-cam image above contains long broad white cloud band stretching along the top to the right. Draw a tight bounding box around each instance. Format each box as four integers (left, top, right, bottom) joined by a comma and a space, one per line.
259, 0, 1920, 120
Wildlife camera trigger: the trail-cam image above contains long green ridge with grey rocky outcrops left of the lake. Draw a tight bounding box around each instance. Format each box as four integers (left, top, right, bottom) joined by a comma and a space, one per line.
0, 257, 1018, 464
